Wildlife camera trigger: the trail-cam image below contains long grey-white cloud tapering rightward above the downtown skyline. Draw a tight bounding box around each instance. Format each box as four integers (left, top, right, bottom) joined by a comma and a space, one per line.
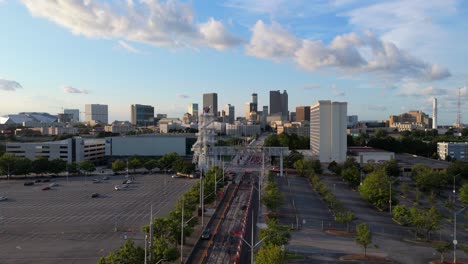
246, 20, 450, 80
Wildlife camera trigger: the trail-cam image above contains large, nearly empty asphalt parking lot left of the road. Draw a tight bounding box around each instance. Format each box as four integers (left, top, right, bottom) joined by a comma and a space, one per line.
0, 175, 196, 264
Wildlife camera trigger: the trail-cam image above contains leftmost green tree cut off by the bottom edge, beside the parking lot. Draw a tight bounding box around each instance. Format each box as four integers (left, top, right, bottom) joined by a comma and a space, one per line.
98, 239, 145, 264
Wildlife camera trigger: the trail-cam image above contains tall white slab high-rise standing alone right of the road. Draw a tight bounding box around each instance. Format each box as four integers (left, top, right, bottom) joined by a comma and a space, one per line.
310, 100, 348, 162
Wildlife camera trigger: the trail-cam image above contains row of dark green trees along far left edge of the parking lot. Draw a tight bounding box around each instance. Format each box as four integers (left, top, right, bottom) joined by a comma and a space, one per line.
0, 153, 96, 178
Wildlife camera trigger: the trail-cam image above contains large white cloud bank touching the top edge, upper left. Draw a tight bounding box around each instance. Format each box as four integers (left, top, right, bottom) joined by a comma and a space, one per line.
21, 0, 240, 49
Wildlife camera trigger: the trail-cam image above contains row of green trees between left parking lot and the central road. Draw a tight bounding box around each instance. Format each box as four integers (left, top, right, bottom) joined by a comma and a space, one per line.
98, 167, 223, 264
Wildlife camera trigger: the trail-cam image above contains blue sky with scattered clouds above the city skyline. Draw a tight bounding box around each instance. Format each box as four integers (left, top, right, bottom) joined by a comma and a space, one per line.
0, 0, 468, 124
